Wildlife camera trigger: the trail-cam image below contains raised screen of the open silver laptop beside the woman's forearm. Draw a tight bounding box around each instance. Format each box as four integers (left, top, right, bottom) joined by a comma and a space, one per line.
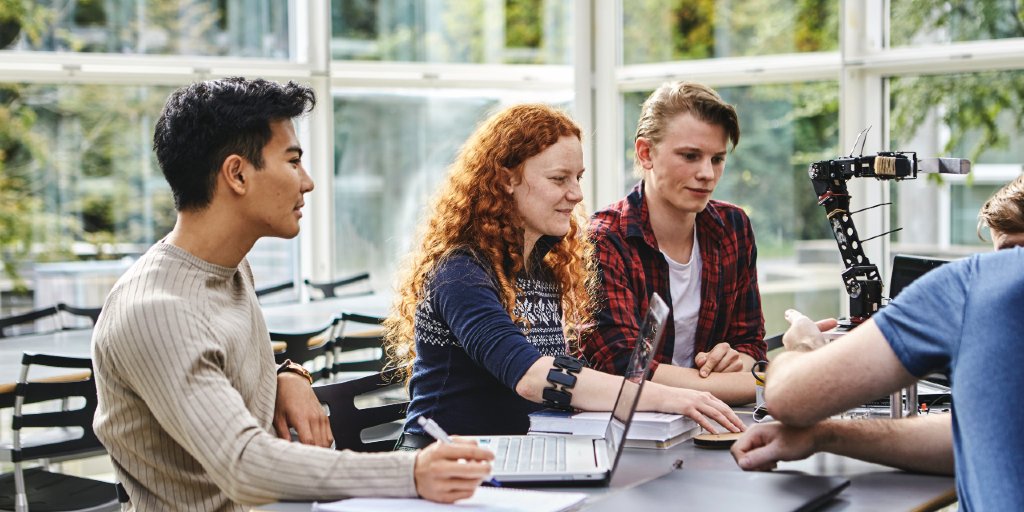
605, 294, 669, 464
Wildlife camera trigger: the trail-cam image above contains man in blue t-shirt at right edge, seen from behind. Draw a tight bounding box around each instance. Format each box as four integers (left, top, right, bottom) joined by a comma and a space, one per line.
732, 176, 1024, 510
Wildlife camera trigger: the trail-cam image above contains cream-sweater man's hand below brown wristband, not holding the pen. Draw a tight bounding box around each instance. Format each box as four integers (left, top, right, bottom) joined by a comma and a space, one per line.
273, 372, 334, 447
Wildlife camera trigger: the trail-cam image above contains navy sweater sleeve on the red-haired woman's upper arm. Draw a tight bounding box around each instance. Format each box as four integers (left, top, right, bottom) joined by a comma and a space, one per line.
429, 255, 541, 389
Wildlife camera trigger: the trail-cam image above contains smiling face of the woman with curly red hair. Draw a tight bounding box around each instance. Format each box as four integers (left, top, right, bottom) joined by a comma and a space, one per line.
512, 136, 584, 248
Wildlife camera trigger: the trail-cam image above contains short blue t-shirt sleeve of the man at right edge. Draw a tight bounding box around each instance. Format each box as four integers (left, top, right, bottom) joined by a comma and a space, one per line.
873, 257, 977, 377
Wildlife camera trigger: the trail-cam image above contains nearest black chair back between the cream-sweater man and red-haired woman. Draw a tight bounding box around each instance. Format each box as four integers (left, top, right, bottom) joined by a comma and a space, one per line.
313, 369, 409, 452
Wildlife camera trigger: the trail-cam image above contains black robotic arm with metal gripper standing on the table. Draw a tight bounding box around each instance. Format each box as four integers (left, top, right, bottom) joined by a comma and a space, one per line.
808, 149, 971, 330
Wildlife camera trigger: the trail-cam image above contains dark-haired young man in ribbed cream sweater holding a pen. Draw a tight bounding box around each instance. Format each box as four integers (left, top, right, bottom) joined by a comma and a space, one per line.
92, 78, 493, 511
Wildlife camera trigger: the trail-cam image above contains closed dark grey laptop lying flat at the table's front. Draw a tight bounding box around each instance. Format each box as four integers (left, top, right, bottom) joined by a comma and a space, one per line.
587, 469, 850, 512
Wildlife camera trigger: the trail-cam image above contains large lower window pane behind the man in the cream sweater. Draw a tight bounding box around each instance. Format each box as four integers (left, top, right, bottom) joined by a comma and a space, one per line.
0, 83, 297, 306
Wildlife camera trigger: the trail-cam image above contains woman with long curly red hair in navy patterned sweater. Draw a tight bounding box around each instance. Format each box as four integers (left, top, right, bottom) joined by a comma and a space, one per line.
385, 104, 743, 447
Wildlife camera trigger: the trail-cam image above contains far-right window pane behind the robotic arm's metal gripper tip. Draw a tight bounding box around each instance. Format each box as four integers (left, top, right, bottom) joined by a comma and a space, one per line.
889, 71, 1024, 257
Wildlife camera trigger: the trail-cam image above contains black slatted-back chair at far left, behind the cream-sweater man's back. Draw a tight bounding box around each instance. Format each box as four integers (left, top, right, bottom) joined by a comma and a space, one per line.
0, 352, 120, 512
